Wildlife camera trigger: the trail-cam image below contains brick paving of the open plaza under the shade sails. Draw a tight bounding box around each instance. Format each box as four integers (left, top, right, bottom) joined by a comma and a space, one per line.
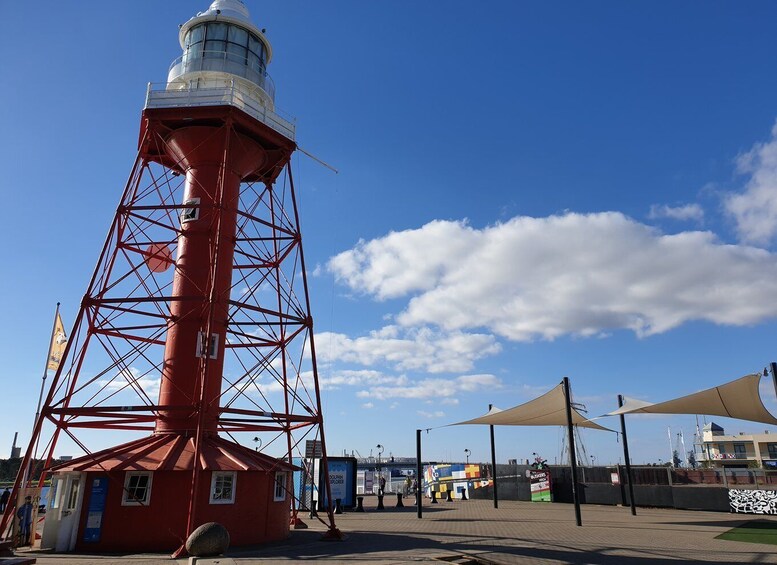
12, 497, 777, 565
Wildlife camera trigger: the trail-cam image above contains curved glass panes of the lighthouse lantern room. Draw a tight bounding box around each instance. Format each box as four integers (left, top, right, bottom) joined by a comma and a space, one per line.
182, 22, 267, 86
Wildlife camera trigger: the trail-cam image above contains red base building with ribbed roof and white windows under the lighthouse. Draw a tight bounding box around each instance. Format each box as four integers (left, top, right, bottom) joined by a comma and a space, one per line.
41, 434, 294, 553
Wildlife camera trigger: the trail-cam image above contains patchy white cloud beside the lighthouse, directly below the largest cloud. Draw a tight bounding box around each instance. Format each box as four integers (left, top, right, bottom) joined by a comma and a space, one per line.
316, 325, 501, 373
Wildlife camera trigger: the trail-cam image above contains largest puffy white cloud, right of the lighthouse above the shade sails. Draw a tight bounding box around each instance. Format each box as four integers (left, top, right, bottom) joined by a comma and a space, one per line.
328, 212, 777, 340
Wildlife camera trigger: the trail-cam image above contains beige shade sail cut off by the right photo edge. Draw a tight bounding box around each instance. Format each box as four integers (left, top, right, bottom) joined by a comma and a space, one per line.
607, 374, 777, 425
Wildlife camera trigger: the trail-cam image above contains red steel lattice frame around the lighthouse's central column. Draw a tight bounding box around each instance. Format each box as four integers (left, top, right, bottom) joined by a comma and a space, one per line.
0, 107, 336, 535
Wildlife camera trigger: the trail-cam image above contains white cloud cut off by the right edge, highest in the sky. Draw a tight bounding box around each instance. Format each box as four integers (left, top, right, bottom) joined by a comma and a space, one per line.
724, 124, 777, 244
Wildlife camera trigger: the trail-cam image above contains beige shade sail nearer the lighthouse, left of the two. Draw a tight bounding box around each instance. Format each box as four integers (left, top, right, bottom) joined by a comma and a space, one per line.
450, 384, 613, 432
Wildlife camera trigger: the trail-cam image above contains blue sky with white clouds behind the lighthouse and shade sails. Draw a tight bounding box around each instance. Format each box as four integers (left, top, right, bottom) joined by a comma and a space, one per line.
0, 0, 777, 468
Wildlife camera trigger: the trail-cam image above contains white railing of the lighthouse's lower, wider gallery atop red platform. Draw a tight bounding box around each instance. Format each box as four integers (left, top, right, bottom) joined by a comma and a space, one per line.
144, 83, 296, 141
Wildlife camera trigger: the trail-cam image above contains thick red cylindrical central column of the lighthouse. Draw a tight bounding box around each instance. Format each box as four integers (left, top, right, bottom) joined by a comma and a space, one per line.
156, 126, 266, 432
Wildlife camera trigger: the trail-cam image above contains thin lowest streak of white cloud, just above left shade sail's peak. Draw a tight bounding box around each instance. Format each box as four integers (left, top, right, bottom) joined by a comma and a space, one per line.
356, 375, 502, 401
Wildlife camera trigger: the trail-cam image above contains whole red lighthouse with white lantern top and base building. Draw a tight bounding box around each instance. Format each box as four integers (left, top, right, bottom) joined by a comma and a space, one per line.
2, 0, 336, 551
